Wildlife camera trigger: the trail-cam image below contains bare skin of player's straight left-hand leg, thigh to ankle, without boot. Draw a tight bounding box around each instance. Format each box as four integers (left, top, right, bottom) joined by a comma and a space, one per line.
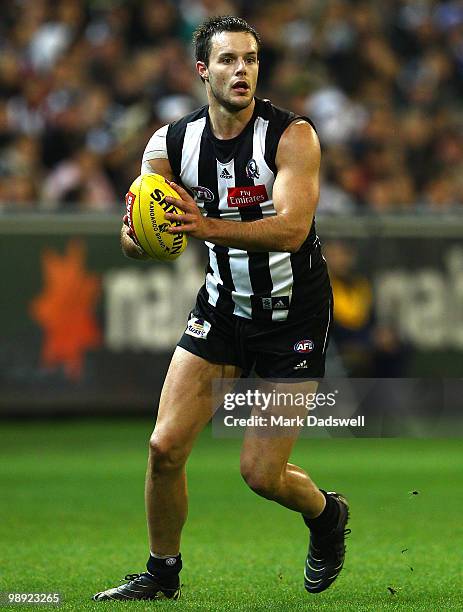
145, 347, 240, 556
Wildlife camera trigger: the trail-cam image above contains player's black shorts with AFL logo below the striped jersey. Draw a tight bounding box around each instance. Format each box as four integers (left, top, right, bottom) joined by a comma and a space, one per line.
178, 292, 333, 378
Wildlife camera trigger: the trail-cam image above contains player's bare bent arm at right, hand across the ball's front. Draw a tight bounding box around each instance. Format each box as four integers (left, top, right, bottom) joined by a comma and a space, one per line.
166, 120, 320, 253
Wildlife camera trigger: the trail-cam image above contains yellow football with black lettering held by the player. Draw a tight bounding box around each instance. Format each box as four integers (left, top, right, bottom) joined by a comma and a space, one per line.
125, 174, 187, 261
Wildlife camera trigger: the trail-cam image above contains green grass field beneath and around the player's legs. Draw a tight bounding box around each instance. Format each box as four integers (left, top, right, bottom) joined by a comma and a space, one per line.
0, 420, 463, 612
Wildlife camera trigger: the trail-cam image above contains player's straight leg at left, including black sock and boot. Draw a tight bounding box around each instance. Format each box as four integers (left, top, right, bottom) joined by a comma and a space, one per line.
93, 347, 241, 601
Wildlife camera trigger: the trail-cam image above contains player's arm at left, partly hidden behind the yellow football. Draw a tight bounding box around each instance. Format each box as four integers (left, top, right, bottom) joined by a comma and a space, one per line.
121, 126, 174, 259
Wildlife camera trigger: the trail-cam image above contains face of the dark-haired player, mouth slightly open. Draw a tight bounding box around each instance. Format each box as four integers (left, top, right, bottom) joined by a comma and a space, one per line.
198, 32, 259, 112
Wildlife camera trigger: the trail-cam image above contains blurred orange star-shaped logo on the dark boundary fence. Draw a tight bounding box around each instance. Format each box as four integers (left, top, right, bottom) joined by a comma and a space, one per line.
30, 240, 101, 380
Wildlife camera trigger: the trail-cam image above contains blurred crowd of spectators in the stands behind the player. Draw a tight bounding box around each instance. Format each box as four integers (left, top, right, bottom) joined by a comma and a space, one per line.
0, 0, 463, 214
